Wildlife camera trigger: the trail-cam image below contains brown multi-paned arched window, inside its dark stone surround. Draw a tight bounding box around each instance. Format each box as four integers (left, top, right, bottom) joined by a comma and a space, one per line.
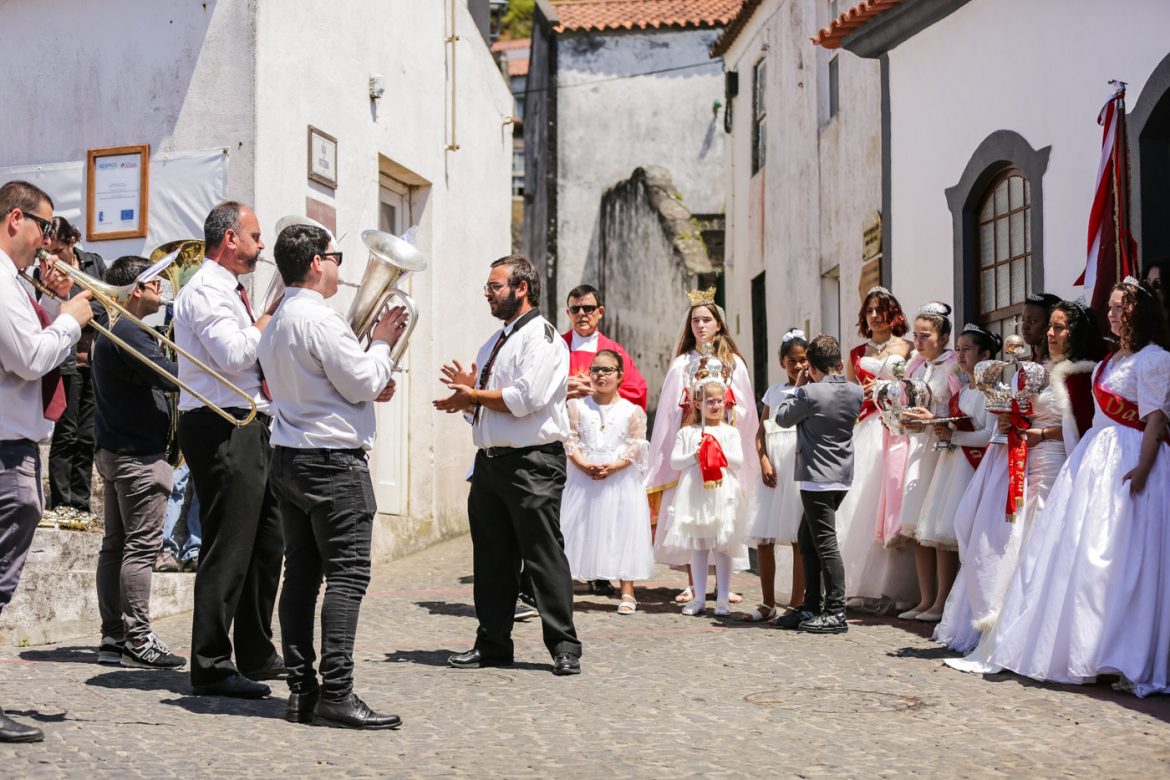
976, 168, 1032, 336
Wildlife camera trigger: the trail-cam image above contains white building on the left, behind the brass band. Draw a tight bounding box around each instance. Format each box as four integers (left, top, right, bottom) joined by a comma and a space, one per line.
0, 0, 512, 554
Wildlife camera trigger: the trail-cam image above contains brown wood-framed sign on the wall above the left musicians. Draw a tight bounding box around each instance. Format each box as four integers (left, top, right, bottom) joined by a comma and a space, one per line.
85, 144, 150, 241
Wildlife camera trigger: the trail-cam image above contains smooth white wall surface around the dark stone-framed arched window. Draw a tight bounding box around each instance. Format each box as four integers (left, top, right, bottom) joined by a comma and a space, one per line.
889, 0, 1170, 318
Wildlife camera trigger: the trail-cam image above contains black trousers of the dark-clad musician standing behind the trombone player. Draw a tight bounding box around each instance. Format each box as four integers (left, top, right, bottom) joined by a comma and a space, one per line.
49, 367, 94, 512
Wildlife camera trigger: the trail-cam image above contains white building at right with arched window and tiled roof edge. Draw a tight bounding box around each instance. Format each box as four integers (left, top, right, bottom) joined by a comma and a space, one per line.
818, 0, 1170, 339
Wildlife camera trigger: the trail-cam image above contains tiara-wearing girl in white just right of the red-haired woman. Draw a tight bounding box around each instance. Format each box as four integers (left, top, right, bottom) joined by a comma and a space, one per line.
897, 302, 958, 622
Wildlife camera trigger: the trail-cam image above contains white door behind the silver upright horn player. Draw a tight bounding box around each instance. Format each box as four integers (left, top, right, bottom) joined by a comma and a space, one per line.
371, 177, 411, 515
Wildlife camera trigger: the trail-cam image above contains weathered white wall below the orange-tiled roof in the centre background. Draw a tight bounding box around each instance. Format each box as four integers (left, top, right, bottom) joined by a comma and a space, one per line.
557, 30, 724, 326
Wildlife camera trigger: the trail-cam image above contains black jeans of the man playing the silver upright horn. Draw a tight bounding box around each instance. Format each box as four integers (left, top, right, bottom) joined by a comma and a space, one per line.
271, 447, 378, 700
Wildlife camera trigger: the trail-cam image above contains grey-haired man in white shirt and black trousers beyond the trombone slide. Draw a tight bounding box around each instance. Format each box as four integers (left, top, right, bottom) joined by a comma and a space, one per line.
174, 201, 288, 698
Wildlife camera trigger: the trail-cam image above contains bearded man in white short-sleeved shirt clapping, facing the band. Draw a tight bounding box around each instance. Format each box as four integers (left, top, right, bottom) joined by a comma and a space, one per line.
434, 255, 581, 675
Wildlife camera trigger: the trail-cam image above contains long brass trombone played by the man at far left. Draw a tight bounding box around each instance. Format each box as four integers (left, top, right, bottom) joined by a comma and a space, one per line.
20, 249, 256, 428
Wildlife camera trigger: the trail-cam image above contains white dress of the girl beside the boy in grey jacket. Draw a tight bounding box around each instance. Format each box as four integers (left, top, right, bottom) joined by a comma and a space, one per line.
748, 382, 804, 545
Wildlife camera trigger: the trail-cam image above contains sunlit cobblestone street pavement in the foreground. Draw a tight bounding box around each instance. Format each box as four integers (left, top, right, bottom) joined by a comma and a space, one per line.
0, 537, 1170, 778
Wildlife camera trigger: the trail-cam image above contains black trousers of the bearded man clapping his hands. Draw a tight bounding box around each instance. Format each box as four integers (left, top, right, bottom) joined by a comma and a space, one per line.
467, 446, 581, 660
